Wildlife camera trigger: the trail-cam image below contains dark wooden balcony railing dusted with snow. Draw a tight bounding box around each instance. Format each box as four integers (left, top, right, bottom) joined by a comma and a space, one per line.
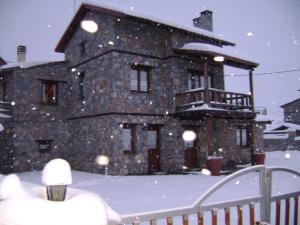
176, 88, 251, 110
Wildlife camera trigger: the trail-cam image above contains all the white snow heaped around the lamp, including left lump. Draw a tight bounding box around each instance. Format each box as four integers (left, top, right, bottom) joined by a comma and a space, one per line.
0, 171, 121, 225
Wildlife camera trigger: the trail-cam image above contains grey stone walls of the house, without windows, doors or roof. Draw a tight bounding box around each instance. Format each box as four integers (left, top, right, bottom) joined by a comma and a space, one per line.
0, 4, 260, 175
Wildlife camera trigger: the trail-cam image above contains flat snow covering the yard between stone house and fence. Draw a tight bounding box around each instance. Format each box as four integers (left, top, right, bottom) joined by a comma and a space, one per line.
0, 151, 300, 214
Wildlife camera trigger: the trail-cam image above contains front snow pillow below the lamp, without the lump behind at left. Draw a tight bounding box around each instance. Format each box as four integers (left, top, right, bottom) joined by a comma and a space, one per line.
0, 188, 121, 225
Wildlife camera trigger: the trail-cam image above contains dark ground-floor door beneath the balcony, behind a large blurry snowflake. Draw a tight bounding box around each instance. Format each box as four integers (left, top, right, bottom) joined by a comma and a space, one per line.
184, 131, 198, 169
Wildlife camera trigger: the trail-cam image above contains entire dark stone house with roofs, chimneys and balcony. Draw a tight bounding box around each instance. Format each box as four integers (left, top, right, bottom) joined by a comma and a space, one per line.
0, 4, 261, 175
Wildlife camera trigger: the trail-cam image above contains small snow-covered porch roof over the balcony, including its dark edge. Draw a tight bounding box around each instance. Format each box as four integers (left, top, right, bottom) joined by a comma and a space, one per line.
177, 42, 258, 67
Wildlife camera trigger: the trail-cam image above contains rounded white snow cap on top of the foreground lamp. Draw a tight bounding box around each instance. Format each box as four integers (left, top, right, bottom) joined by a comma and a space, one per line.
42, 159, 72, 186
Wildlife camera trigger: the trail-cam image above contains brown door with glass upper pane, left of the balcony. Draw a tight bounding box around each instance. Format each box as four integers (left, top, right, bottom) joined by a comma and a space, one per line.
147, 126, 160, 173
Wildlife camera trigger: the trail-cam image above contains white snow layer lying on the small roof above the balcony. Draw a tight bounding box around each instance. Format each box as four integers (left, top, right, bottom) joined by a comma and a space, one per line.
180, 42, 258, 64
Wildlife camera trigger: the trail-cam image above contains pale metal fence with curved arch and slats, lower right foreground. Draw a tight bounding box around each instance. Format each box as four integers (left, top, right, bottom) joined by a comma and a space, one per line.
121, 165, 300, 225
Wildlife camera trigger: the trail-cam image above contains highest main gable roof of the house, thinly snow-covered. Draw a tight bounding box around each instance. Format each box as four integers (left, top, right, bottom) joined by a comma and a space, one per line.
55, 1, 235, 52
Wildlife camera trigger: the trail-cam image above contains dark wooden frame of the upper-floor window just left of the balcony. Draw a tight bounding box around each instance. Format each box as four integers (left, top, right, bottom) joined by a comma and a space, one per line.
130, 65, 152, 93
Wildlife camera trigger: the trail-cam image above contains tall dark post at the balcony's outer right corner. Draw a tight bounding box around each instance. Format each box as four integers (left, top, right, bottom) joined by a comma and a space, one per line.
249, 68, 256, 165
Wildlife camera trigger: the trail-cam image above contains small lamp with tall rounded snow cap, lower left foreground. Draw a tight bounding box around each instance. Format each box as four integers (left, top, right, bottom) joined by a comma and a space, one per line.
42, 159, 72, 201
